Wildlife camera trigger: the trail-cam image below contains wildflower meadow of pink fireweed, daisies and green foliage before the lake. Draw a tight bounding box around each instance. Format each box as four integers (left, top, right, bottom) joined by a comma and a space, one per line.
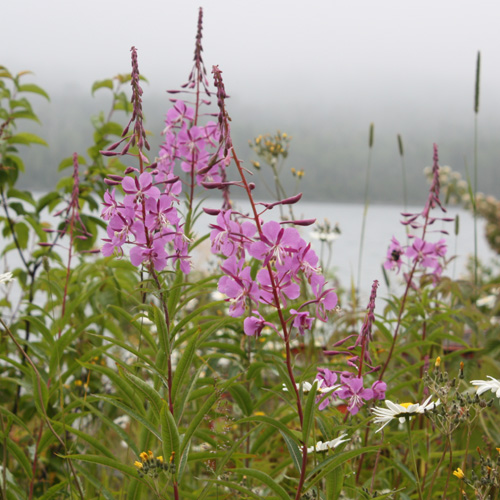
0, 9, 500, 500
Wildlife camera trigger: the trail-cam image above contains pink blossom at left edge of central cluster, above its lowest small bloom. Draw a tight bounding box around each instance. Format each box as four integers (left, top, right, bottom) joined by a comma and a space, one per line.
218, 255, 260, 317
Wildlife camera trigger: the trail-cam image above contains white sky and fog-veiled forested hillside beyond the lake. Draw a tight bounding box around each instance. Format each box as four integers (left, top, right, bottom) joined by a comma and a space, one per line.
0, 0, 500, 204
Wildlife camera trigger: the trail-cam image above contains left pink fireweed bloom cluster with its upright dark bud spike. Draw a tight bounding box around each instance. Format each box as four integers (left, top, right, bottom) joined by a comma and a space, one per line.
101, 47, 190, 273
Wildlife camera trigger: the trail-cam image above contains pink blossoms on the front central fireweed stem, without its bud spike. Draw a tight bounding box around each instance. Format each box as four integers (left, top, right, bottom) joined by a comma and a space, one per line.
210, 210, 337, 335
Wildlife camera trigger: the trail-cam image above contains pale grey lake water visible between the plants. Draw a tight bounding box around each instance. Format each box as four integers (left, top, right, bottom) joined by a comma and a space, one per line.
0, 200, 496, 297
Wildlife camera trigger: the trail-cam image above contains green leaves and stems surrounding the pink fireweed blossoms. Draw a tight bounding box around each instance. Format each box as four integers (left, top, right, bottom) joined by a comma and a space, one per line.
0, 44, 500, 500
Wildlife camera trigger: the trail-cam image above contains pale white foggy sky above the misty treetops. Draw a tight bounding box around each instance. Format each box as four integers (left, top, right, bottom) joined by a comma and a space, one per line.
0, 0, 500, 107
